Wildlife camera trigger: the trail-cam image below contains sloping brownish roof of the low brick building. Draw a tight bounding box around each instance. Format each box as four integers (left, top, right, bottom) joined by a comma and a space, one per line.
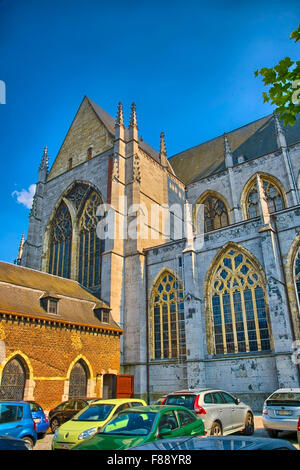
0, 261, 121, 331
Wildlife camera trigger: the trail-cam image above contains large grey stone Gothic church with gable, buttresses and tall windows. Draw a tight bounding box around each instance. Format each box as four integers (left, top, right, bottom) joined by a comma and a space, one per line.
21, 97, 300, 410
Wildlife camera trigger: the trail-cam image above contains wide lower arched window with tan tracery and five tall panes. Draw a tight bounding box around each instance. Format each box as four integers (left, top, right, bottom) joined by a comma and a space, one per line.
209, 249, 271, 354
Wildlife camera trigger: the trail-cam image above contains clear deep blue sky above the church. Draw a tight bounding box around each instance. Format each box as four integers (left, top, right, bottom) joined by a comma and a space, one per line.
0, 0, 300, 262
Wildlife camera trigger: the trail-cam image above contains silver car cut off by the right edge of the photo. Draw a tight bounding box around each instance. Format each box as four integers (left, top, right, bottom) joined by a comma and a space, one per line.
262, 388, 300, 438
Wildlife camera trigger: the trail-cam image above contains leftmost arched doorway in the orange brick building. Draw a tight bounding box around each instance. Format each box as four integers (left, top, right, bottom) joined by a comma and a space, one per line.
0, 358, 26, 400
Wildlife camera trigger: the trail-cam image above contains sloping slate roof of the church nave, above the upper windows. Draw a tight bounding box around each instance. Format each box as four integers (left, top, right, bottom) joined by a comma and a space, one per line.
169, 114, 300, 184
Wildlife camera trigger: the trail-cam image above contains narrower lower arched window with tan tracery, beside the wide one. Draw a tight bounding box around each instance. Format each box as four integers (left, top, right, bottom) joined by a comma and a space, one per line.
149, 272, 186, 359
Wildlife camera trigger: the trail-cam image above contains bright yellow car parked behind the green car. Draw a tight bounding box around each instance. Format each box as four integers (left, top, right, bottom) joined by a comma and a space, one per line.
52, 398, 146, 450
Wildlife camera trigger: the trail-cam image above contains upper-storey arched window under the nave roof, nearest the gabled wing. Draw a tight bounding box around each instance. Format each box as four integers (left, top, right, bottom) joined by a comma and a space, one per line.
201, 195, 229, 232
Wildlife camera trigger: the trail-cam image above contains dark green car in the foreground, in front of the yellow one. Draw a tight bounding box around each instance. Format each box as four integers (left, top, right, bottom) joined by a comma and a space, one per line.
71, 405, 205, 450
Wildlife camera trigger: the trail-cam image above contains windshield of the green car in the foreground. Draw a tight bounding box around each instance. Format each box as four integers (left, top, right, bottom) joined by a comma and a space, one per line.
101, 411, 156, 436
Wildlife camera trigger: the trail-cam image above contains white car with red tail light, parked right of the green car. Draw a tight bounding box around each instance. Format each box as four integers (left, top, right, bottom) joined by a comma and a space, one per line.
162, 388, 254, 436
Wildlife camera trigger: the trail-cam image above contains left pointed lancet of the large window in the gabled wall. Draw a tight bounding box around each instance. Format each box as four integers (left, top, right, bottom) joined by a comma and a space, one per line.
48, 202, 72, 278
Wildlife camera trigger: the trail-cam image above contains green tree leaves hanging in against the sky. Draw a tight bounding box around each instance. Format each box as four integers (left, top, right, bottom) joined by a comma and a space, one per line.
254, 24, 300, 126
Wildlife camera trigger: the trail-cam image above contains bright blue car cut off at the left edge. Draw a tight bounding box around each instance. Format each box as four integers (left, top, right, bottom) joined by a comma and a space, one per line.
0, 400, 37, 449
